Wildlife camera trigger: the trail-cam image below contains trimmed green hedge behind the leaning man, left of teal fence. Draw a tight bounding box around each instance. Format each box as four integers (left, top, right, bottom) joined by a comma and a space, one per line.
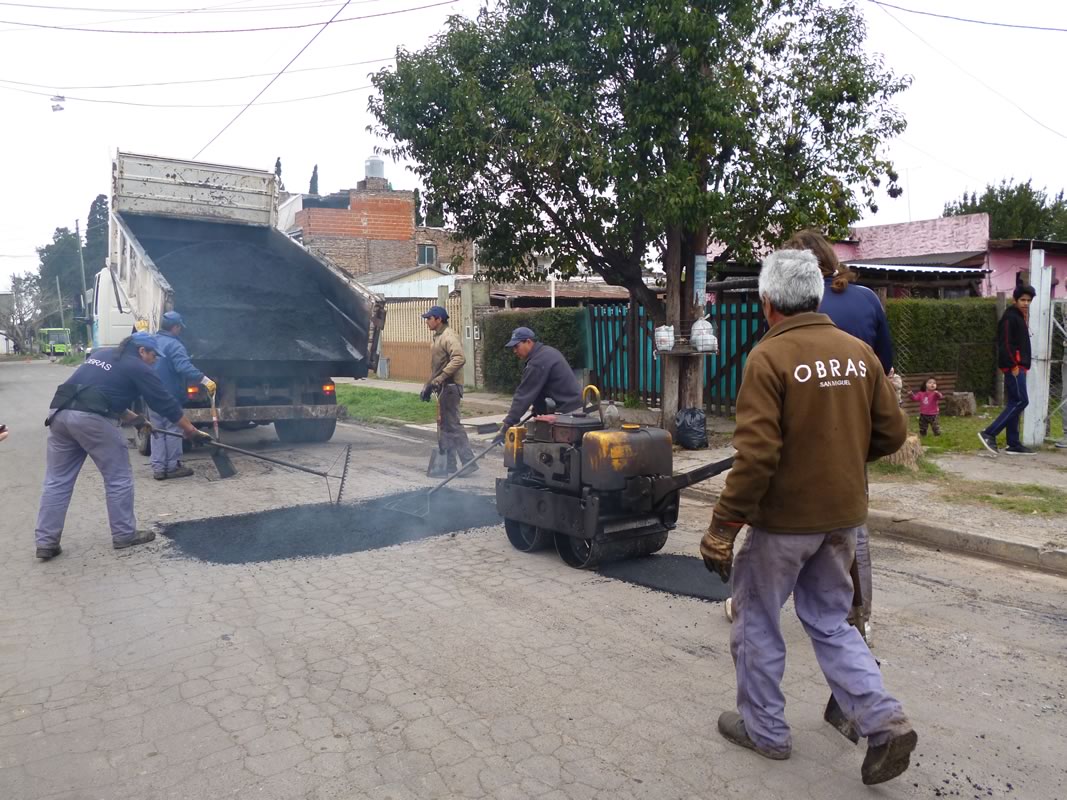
481, 308, 588, 393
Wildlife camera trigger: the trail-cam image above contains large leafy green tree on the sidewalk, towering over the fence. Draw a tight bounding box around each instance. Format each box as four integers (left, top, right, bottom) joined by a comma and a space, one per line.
370, 0, 908, 422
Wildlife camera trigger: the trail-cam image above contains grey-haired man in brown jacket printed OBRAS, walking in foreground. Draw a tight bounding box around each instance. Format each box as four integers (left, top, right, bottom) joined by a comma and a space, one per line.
700, 250, 918, 784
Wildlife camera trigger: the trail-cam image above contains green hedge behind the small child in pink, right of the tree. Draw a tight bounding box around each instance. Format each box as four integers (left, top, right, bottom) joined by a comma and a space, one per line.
886, 298, 997, 398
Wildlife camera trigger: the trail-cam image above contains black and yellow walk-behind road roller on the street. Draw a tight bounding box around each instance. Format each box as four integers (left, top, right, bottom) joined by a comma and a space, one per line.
496, 386, 733, 570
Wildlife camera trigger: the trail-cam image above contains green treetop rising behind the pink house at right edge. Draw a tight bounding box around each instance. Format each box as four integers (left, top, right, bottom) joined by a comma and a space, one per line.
944, 179, 1067, 241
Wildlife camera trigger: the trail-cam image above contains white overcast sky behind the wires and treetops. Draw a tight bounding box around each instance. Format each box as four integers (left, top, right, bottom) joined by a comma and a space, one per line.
0, 0, 1067, 288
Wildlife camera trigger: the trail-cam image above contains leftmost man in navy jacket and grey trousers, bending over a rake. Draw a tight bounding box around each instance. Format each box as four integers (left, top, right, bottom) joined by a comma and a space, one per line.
35, 333, 203, 561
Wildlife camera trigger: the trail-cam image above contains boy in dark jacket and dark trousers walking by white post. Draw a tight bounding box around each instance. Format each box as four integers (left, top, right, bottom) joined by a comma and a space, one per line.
978, 286, 1037, 455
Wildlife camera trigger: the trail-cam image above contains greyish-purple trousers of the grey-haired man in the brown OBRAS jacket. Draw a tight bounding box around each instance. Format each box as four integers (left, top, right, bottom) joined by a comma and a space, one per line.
730, 528, 911, 752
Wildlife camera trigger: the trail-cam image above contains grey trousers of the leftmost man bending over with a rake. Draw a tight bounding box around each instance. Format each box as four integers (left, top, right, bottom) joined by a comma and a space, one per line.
35, 410, 137, 547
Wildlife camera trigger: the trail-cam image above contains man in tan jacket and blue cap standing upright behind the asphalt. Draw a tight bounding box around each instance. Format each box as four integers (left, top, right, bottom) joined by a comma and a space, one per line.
419, 305, 478, 475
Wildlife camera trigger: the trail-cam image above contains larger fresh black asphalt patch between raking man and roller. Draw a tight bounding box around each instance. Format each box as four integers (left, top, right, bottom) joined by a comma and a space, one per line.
162, 489, 500, 564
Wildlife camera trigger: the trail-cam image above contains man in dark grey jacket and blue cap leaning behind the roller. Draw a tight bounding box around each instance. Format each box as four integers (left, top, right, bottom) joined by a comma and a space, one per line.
494, 326, 582, 442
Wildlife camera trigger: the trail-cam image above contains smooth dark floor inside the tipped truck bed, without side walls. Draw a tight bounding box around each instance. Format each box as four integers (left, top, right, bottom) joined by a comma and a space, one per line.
149, 241, 352, 362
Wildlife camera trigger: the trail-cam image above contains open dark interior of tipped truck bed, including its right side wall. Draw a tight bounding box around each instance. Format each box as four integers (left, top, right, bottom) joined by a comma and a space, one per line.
118, 213, 371, 378
